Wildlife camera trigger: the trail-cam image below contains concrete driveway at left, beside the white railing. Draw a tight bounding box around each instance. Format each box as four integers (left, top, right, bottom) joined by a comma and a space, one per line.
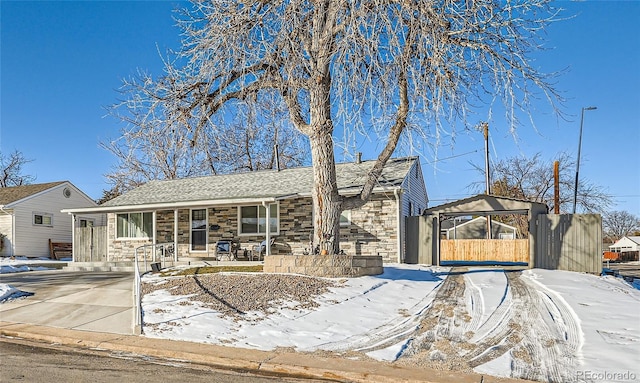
0, 271, 134, 334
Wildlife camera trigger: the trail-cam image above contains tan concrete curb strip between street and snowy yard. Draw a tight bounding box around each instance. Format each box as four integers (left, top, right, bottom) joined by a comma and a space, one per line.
0, 321, 526, 383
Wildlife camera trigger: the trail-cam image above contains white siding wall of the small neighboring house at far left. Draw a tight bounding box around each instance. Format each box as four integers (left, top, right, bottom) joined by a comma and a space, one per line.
14, 183, 100, 257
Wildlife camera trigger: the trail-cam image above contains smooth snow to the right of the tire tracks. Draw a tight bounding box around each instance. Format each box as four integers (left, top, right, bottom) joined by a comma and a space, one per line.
524, 269, 640, 382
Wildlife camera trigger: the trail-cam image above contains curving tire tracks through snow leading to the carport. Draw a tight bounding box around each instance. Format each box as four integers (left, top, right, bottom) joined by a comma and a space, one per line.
392, 269, 582, 382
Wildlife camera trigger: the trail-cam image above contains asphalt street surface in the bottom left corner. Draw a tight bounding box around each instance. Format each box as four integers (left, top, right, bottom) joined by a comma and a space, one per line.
0, 338, 326, 383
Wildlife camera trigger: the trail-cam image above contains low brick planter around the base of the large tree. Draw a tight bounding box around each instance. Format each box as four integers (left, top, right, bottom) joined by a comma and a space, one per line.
263, 255, 383, 278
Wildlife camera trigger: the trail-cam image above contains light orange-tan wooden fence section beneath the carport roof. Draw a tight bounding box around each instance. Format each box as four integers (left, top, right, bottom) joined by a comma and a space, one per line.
440, 239, 530, 263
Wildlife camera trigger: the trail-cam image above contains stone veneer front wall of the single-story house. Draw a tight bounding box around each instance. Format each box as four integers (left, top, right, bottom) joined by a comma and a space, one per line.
107, 195, 398, 262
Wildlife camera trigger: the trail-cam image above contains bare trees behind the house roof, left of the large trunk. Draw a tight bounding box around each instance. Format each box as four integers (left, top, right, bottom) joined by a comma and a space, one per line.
104, 91, 308, 198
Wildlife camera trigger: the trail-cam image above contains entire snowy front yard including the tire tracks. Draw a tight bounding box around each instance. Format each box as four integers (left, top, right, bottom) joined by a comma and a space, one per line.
142, 265, 640, 382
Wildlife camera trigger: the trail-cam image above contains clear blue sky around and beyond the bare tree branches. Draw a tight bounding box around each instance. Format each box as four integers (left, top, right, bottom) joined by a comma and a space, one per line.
0, 0, 640, 216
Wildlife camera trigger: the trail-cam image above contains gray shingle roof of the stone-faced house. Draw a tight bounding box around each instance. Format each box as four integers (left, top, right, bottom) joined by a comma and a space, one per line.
101, 157, 417, 207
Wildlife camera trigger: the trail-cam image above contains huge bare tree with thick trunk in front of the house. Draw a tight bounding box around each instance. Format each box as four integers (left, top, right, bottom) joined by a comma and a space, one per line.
114, 0, 558, 253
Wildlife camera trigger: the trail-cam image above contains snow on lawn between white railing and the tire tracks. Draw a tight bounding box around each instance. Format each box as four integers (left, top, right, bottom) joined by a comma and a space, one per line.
142, 265, 443, 359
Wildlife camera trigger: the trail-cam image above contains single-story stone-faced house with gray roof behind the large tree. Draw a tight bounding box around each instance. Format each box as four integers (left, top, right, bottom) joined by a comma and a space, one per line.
65, 157, 428, 262
